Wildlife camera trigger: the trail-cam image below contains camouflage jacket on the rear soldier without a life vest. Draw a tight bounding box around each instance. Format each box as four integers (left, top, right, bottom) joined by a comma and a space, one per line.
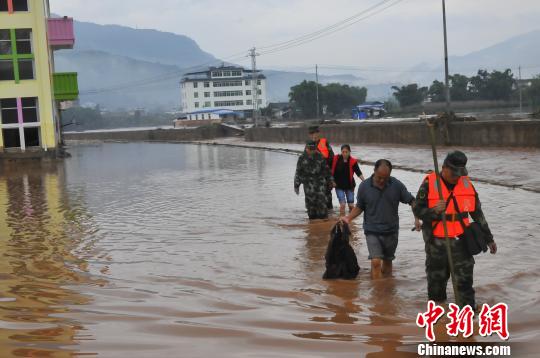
294, 152, 334, 188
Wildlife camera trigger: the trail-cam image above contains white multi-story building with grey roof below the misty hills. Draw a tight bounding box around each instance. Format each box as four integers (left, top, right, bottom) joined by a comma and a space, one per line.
181, 65, 268, 119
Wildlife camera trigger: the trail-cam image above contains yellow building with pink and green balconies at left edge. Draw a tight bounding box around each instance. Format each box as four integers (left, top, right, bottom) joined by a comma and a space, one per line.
0, 0, 79, 155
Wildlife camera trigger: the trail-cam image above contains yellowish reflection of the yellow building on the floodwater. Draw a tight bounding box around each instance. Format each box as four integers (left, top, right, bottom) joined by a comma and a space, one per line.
0, 163, 98, 356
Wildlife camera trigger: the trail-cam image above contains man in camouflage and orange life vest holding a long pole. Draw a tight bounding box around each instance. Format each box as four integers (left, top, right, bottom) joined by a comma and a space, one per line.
414, 151, 497, 309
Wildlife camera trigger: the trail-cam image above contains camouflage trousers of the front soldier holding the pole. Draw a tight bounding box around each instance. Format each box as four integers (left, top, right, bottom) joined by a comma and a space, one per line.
426, 238, 475, 309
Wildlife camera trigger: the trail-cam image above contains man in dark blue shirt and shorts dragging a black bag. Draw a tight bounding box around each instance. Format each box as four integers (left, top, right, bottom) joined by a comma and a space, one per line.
341, 159, 421, 279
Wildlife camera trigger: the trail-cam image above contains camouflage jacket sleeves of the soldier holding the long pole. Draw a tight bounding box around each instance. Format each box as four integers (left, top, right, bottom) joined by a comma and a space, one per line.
413, 179, 493, 243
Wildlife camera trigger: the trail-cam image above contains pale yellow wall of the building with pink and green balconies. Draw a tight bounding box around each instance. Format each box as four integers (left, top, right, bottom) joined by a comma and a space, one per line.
0, 0, 56, 150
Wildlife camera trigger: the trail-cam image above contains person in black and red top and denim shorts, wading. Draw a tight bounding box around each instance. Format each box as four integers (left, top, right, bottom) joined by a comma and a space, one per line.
332, 144, 364, 215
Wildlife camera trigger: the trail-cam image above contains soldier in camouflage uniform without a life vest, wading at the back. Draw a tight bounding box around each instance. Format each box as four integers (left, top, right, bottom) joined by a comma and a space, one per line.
294, 141, 334, 219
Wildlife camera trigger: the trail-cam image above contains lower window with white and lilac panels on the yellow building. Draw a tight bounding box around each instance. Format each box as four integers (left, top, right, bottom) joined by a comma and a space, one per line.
0, 97, 40, 150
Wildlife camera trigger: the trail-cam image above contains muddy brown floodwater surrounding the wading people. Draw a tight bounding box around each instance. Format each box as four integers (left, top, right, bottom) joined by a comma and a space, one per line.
0, 143, 540, 357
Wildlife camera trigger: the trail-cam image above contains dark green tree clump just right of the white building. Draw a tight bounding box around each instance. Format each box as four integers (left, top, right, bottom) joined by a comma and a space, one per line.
289, 80, 367, 118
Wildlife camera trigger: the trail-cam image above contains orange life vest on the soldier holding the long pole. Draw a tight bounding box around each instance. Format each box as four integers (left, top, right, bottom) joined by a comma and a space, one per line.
426, 173, 476, 238
